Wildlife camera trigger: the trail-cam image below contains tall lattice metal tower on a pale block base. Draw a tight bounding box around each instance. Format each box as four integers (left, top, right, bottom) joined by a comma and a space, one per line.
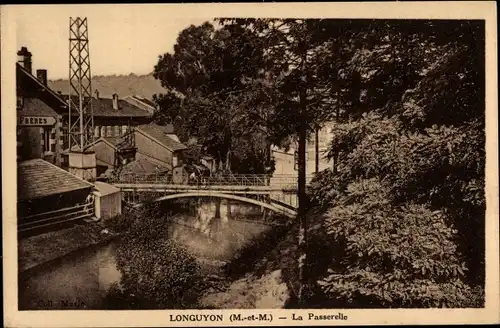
68, 17, 96, 180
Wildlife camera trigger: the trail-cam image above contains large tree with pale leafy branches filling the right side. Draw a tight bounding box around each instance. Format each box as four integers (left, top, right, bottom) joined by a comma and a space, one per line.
311, 21, 485, 307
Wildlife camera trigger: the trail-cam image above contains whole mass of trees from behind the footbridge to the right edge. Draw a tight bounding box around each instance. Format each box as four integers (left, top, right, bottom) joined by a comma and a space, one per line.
151, 19, 485, 307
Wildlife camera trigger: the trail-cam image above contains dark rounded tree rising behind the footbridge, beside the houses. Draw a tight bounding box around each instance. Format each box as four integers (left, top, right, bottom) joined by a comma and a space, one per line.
154, 23, 270, 173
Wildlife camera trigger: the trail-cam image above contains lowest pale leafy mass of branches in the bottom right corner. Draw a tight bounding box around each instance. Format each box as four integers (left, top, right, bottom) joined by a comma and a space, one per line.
322, 178, 470, 307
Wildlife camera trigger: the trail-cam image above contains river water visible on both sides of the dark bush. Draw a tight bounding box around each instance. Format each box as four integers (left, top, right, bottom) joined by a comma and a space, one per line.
19, 203, 278, 310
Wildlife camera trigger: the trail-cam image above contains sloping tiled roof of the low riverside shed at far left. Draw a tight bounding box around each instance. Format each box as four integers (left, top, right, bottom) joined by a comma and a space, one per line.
17, 159, 93, 200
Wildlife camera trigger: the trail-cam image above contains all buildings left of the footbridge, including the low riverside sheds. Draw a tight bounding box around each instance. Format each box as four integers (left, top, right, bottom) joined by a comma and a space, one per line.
16, 47, 186, 226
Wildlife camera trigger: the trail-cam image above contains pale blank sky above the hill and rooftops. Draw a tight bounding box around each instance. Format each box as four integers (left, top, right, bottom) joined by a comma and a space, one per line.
15, 5, 212, 80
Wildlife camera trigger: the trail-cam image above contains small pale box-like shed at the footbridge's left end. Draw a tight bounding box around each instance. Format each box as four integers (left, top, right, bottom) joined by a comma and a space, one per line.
94, 181, 122, 220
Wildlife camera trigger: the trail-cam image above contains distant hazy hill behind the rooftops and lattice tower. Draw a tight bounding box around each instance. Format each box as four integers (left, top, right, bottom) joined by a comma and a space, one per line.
48, 74, 165, 99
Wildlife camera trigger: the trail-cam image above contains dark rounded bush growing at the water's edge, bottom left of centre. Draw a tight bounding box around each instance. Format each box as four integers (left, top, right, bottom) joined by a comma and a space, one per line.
106, 204, 204, 309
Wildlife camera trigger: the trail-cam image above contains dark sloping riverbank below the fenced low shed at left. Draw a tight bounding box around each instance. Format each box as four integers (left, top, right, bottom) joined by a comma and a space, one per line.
18, 222, 118, 273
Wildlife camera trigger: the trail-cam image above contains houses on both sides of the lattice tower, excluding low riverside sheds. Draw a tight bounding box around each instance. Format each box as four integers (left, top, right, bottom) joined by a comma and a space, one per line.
16, 47, 186, 176
